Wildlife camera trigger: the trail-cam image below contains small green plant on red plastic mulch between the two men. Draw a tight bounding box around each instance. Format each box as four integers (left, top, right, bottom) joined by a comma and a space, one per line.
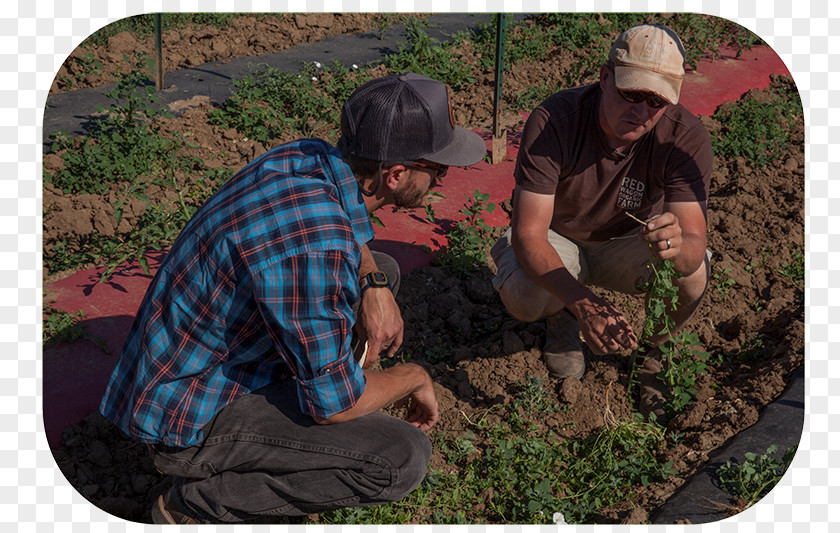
438, 189, 496, 274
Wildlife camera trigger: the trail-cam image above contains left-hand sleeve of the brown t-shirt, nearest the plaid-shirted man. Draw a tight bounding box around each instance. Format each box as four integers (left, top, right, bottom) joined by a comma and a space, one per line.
514, 106, 562, 194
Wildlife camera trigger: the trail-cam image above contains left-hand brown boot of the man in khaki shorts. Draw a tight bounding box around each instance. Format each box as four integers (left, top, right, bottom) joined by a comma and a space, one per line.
543, 310, 586, 379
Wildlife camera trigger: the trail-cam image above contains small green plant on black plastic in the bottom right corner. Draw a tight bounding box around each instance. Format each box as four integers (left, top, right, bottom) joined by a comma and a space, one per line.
716, 444, 797, 507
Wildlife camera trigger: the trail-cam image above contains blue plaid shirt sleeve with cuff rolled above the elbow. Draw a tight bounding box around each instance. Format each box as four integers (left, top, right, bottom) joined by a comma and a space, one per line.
254, 250, 365, 418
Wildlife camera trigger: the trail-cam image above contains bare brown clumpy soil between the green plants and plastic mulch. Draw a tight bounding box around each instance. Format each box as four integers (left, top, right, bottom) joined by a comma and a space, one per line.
44, 15, 805, 523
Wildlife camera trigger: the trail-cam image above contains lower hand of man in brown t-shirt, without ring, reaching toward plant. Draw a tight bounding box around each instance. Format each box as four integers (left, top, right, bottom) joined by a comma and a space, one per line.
569, 294, 638, 355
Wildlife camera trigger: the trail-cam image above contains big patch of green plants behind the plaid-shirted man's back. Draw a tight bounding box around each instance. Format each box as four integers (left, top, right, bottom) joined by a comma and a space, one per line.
44, 53, 231, 281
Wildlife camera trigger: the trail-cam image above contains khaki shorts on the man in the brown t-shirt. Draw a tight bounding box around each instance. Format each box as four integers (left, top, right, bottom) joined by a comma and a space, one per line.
490, 229, 652, 294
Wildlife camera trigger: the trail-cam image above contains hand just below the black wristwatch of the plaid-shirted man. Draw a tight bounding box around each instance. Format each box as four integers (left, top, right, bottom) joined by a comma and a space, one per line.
356, 287, 403, 368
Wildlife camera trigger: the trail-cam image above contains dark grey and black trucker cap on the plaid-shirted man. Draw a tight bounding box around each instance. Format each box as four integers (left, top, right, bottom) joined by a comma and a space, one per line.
341, 72, 487, 167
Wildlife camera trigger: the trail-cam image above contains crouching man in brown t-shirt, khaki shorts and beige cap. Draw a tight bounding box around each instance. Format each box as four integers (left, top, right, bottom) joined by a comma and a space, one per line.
492, 25, 712, 419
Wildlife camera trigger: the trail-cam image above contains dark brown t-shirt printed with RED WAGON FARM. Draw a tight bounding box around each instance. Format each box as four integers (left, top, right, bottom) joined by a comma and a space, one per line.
514, 83, 712, 241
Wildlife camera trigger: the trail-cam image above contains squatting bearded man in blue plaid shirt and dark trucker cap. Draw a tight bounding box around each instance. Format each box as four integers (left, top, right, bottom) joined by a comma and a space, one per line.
100, 73, 486, 523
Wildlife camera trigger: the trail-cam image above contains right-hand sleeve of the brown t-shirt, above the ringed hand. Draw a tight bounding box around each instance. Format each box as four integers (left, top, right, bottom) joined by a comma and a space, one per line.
665, 121, 714, 205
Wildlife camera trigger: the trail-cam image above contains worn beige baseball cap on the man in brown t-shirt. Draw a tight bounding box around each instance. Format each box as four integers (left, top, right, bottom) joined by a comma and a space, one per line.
609, 24, 685, 104
